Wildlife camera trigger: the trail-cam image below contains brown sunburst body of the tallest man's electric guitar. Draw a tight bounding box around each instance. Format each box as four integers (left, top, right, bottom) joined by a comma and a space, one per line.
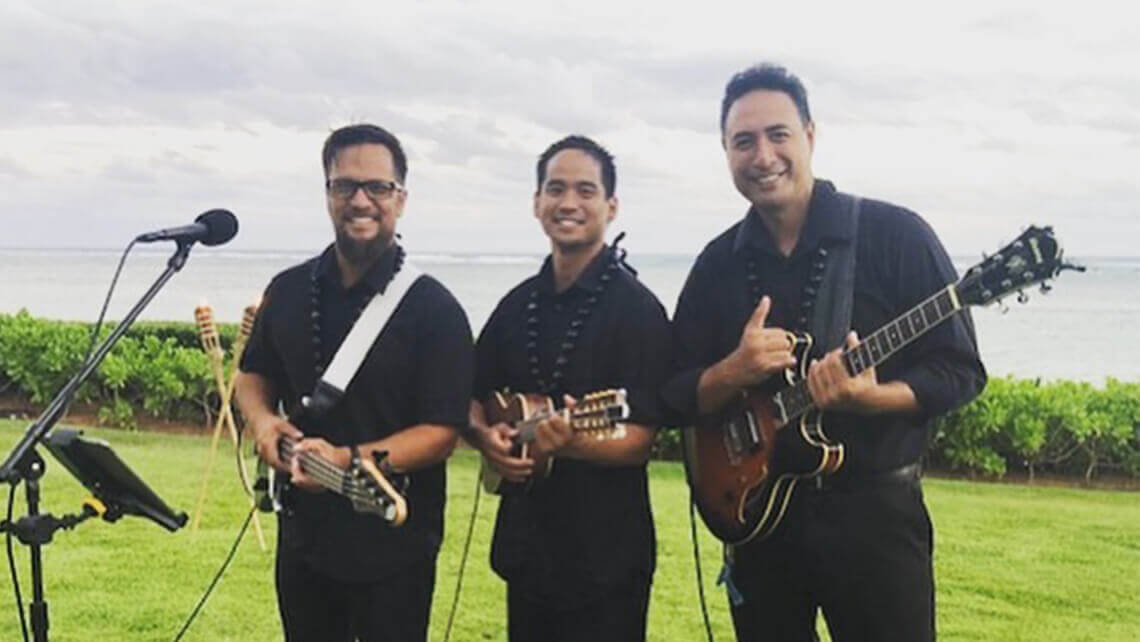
683, 334, 844, 544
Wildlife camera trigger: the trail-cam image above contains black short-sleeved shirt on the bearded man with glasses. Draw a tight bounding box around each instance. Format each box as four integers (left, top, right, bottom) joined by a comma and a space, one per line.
242, 246, 473, 580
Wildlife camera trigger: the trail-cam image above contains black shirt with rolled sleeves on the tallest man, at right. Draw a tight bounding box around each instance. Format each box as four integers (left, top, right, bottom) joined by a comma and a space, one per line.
665, 180, 986, 474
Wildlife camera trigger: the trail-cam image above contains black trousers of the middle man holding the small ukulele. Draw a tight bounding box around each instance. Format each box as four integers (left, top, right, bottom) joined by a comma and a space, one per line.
506, 578, 652, 642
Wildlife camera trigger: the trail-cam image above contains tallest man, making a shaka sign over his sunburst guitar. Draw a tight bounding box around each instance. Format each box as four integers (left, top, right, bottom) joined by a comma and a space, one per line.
665, 65, 985, 642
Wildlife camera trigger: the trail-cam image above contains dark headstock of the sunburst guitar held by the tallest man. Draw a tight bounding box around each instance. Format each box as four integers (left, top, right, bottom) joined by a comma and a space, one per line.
956, 226, 1084, 306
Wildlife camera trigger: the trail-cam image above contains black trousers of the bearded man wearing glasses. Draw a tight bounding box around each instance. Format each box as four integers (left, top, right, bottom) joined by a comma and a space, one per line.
277, 548, 435, 642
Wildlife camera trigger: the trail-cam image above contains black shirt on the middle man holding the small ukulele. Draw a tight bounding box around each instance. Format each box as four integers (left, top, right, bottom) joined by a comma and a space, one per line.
474, 247, 669, 606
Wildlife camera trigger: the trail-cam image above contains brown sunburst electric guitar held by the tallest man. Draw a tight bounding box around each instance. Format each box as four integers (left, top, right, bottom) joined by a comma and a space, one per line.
683, 227, 1084, 544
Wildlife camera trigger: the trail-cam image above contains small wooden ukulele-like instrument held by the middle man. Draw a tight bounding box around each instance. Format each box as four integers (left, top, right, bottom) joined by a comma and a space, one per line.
480, 389, 629, 495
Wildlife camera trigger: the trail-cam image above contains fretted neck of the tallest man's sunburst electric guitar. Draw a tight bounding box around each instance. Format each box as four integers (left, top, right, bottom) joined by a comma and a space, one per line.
773, 284, 963, 423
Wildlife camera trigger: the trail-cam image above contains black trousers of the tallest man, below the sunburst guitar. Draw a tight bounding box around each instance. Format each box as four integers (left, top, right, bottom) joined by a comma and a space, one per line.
732, 480, 935, 642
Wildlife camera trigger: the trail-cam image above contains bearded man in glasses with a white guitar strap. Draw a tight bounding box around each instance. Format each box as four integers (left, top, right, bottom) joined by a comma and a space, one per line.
236, 124, 472, 641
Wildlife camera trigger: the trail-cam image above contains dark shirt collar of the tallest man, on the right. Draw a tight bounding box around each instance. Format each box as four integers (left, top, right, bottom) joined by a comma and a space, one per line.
732, 179, 854, 257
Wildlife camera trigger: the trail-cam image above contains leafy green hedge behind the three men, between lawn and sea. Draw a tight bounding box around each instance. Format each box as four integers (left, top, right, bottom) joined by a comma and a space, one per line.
0, 311, 1140, 479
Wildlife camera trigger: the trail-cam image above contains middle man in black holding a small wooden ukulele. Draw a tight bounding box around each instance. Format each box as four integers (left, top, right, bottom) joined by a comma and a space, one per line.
469, 136, 670, 642
